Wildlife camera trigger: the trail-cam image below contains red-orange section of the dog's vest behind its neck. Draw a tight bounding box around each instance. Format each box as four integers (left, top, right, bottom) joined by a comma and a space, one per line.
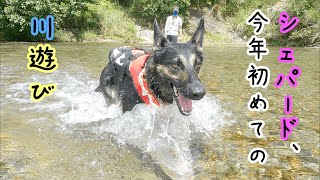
129, 49, 160, 106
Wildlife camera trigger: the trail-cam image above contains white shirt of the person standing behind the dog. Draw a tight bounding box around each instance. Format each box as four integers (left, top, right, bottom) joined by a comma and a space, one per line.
164, 15, 182, 36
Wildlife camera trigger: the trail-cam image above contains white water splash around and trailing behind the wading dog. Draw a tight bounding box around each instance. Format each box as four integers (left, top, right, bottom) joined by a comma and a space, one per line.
7, 70, 227, 178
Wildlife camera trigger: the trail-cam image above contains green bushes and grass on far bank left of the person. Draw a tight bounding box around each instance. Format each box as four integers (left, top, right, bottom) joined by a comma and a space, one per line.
0, 0, 136, 41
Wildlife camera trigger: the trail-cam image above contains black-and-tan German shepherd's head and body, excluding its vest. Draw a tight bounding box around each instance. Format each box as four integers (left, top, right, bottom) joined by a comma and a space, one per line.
96, 18, 206, 115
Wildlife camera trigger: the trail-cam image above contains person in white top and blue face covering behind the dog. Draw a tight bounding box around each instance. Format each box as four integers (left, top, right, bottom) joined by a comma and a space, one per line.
164, 6, 182, 42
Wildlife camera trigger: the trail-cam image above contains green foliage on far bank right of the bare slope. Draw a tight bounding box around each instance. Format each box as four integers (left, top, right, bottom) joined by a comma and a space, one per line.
222, 0, 320, 46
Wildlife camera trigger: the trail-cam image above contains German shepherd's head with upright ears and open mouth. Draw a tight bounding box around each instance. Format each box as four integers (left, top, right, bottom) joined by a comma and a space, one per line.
147, 18, 206, 115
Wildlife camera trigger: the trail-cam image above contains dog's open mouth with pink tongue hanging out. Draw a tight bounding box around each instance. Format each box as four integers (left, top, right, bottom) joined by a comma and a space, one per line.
171, 84, 192, 116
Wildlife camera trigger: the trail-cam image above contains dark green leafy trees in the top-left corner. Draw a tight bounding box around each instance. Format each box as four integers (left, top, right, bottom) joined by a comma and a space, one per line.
0, 0, 95, 41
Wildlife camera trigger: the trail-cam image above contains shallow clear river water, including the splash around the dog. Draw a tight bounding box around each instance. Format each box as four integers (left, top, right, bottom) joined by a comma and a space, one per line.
0, 43, 320, 179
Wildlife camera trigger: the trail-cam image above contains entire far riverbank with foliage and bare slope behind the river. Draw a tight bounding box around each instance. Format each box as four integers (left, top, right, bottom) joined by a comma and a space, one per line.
0, 0, 320, 47
